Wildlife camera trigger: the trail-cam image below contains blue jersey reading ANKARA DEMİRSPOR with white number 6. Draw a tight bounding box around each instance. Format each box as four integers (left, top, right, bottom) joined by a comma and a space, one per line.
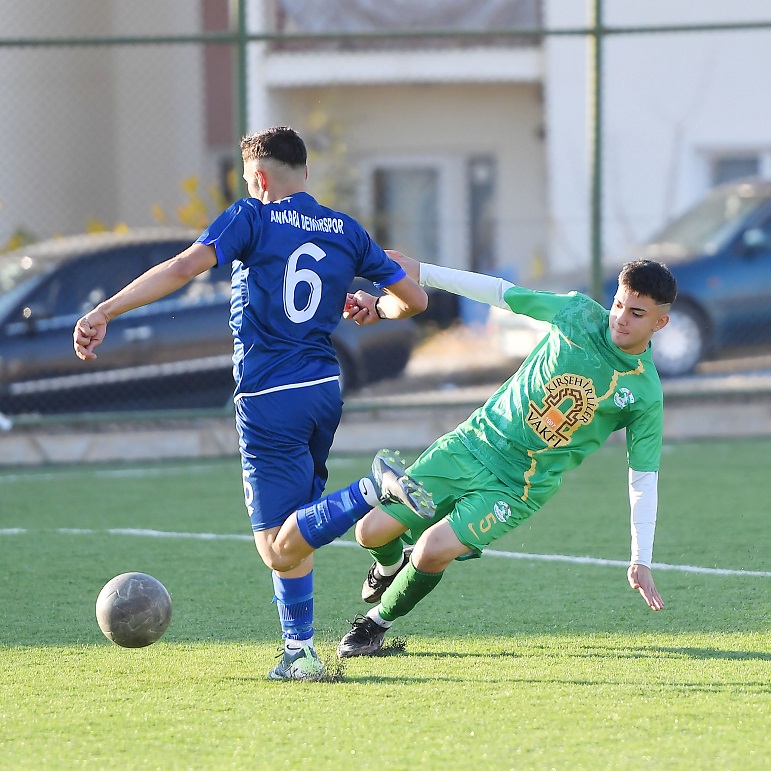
198, 192, 406, 395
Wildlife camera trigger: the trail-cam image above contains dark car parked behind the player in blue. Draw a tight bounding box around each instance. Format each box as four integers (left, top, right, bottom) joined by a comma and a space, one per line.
0, 229, 415, 415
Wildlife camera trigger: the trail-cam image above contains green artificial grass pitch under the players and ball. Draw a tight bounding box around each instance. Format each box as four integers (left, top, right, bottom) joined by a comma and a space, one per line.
0, 440, 771, 771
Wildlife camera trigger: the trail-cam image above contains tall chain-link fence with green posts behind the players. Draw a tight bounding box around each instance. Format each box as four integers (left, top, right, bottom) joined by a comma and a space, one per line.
0, 0, 771, 426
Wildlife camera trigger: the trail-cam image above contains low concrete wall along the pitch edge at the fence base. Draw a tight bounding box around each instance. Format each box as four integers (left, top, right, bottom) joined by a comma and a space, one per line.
0, 386, 771, 468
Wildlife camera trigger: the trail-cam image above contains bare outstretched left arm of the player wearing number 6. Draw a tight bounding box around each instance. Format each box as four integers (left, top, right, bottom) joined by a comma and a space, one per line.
72, 243, 217, 361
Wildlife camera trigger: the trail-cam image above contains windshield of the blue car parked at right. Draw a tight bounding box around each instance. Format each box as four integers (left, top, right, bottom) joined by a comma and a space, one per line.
645, 185, 769, 261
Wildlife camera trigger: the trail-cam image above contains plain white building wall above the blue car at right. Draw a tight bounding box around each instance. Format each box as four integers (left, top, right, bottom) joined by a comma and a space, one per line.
545, 0, 771, 272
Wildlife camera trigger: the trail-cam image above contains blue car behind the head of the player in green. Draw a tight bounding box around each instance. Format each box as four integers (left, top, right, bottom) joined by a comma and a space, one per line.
620, 180, 771, 377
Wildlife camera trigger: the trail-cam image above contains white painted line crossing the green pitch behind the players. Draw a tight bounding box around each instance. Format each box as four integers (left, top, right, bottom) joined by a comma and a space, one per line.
0, 527, 771, 578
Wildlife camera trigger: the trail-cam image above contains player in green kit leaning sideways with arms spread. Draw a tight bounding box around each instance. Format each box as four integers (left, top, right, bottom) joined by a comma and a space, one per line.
337, 257, 677, 658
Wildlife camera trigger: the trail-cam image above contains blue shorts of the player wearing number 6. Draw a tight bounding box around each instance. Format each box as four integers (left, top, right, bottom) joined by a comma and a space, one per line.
236, 380, 343, 531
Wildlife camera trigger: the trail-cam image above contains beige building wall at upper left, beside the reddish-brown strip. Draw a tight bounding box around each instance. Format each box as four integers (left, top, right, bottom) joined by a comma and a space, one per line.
0, 0, 212, 247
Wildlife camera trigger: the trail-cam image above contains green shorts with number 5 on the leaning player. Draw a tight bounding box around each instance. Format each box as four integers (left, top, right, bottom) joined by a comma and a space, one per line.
383, 432, 535, 557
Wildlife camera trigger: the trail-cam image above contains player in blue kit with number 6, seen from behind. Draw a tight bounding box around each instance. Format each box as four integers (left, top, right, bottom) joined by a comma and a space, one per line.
73, 126, 434, 680
